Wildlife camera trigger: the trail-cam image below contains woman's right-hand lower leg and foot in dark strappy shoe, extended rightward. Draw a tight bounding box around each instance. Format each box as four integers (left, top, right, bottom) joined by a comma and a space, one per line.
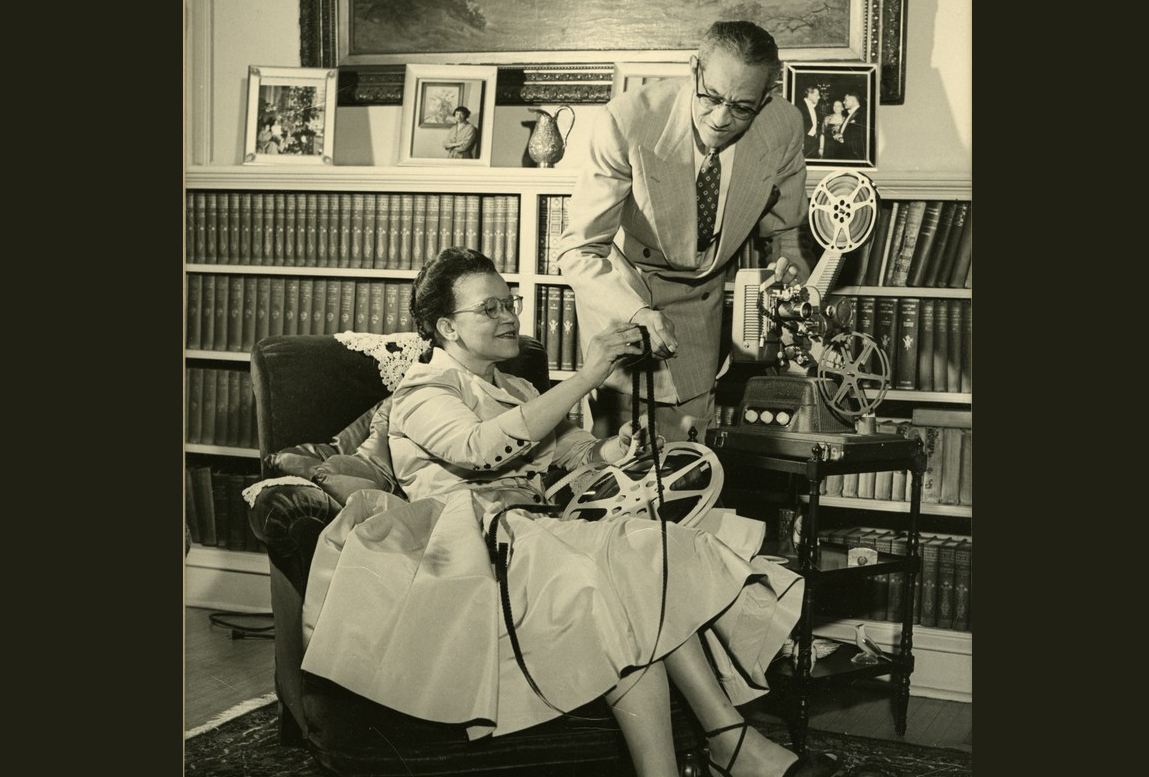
664, 634, 797, 777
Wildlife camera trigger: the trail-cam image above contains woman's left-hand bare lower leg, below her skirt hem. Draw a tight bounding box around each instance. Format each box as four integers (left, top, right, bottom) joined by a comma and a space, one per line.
606, 662, 678, 777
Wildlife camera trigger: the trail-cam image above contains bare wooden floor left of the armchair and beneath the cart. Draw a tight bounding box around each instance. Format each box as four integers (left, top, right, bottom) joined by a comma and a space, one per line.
184, 607, 973, 753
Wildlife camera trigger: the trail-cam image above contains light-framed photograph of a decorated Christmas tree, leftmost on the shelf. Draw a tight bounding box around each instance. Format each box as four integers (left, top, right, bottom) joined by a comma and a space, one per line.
244, 66, 339, 164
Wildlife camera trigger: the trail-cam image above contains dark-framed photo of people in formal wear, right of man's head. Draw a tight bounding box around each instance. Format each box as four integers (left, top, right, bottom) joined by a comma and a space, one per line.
782, 62, 878, 168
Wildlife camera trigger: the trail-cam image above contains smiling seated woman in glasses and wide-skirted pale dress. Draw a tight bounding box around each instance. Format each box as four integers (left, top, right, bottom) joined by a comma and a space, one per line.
303, 248, 836, 777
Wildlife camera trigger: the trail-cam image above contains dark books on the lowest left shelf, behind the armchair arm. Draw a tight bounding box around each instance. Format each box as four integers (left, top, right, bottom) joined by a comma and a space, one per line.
184, 466, 267, 551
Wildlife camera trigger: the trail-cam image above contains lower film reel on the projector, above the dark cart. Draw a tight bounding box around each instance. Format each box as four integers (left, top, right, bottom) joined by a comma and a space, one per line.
818, 332, 890, 418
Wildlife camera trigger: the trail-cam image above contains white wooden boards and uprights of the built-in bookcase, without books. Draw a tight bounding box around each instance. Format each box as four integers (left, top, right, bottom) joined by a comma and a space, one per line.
184, 166, 972, 680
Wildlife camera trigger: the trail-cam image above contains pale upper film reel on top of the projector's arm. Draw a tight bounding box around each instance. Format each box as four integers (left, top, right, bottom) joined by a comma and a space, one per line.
809, 170, 878, 253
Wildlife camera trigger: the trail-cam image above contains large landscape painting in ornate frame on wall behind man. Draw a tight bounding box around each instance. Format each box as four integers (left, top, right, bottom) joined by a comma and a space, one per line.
300, 0, 905, 105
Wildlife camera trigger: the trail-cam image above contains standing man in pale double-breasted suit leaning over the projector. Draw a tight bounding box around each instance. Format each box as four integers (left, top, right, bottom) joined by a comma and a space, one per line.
558, 22, 809, 441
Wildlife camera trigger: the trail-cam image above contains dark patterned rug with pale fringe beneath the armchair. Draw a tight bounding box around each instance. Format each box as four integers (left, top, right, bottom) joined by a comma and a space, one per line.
184, 699, 973, 777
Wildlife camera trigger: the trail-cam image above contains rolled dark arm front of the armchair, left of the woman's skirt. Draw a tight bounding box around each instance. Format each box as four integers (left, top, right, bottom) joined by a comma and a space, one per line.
252, 485, 342, 597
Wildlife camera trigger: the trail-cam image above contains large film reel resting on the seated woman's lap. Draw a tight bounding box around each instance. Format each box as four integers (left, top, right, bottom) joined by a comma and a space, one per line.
562, 441, 723, 526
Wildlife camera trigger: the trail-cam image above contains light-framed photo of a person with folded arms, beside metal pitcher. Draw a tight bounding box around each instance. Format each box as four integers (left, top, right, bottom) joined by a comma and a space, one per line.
399, 64, 499, 167
